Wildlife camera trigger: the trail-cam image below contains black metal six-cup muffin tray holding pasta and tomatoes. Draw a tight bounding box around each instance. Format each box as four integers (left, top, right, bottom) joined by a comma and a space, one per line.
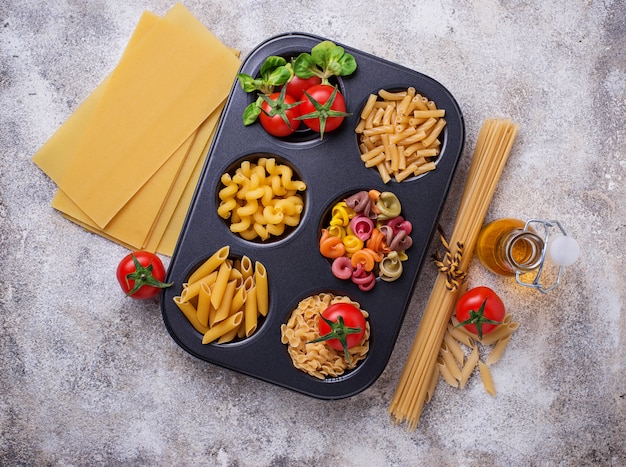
161, 33, 465, 399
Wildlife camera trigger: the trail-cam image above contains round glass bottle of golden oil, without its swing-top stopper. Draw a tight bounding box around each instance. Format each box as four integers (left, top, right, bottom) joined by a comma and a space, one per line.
476, 218, 544, 276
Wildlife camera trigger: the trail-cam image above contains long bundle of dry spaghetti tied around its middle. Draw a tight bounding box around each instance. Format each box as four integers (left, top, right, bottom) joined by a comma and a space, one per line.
389, 118, 518, 430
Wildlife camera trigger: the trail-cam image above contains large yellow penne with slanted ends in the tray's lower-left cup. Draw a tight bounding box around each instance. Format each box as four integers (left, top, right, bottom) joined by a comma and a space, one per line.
174, 246, 269, 344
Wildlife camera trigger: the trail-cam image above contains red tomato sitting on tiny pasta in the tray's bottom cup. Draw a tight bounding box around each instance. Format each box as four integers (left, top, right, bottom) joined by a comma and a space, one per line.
311, 303, 366, 362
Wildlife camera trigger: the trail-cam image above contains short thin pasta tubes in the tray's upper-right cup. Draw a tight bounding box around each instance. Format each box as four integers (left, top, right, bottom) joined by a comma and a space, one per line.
355, 87, 446, 183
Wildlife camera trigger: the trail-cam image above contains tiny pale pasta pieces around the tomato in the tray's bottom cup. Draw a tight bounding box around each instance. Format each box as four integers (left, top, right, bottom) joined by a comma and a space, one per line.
280, 293, 370, 379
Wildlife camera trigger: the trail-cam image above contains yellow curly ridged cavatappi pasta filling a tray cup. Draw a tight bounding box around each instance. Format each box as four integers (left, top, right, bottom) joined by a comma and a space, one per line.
217, 157, 306, 240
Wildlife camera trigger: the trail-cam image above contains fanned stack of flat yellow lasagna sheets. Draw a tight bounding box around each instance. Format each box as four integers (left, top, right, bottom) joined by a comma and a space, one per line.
33, 4, 240, 255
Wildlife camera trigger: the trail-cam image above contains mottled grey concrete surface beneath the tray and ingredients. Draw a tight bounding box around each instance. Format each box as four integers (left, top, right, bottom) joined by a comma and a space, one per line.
0, 0, 626, 466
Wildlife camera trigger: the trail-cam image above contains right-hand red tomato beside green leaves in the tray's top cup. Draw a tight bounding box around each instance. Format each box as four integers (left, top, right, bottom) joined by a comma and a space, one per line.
300, 84, 350, 136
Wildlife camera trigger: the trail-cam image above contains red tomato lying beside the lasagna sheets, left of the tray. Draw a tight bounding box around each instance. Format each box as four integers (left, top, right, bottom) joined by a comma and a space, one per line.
117, 251, 172, 300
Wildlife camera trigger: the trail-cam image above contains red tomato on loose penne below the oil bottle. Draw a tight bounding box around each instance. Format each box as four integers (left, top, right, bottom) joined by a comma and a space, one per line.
456, 287, 505, 339
